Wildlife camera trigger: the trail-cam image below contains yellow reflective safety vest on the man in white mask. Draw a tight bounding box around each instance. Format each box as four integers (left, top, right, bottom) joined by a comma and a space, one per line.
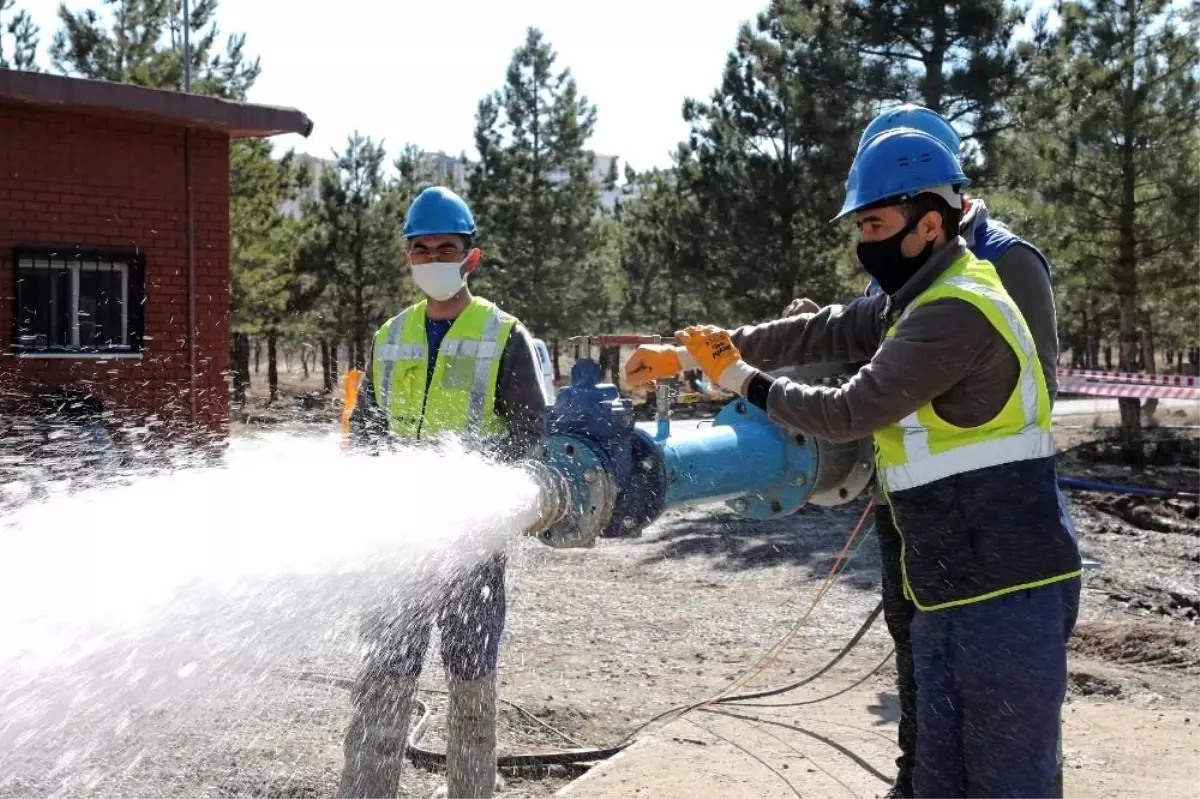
371, 296, 517, 439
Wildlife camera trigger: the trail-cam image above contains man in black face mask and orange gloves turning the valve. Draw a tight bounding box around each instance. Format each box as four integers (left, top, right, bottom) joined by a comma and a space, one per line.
625, 128, 1081, 799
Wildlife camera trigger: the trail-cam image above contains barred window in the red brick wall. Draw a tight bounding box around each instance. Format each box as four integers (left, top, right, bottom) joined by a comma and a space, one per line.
12, 248, 145, 354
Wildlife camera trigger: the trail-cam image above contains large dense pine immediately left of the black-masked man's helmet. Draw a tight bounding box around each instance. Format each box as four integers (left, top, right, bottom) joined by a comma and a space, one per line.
678, 0, 865, 322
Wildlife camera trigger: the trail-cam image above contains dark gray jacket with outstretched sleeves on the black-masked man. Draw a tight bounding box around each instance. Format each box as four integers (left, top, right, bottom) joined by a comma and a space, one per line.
732, 238, 1052, 441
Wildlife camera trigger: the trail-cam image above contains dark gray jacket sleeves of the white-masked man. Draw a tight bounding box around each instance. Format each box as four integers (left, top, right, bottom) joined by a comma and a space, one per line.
350, 307, 546, 461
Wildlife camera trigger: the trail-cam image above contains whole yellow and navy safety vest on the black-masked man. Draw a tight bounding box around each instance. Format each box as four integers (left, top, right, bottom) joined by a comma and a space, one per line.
875, 251, 1081, 611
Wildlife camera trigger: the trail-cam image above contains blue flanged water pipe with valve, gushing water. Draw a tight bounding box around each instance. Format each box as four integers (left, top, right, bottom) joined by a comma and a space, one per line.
529, 358, 872, 547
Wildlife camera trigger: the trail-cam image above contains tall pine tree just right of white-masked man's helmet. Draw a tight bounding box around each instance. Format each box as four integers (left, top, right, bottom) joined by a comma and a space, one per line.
468, 28, 600, 337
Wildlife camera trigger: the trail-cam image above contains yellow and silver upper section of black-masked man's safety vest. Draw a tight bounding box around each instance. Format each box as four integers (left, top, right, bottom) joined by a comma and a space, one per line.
875, 252, 1055, 492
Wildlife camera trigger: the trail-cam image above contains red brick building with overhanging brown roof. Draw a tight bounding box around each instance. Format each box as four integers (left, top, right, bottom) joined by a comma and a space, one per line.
0, 70, 312, 435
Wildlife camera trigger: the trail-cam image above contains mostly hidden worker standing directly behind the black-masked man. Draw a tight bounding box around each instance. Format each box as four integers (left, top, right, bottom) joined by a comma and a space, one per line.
784, 103, 1066, 799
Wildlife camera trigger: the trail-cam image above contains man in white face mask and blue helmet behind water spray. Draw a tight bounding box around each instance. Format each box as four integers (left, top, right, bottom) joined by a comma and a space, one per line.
340, 186, 546, 799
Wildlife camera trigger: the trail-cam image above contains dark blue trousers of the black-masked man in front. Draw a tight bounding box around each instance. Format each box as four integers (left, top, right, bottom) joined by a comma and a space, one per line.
912, 578, 1080, 799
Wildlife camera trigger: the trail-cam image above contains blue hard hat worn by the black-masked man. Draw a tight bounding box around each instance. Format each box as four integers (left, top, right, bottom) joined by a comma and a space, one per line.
833, 127, 971, 222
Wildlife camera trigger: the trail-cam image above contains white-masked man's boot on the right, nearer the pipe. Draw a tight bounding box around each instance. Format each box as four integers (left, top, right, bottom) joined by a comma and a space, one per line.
433, 672, 504, 799
